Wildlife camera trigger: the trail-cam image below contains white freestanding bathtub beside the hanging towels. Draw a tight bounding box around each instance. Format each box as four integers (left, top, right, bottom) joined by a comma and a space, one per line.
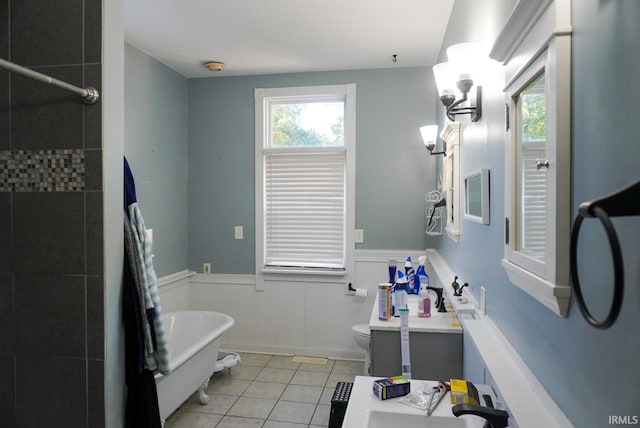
155, 311, 234, 421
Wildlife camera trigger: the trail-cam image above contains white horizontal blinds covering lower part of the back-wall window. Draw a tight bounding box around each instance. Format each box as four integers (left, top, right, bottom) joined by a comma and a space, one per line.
264, 147, 346, 270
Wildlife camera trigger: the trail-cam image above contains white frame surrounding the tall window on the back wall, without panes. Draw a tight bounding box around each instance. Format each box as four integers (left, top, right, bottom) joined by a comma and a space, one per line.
254, 84, 356, 290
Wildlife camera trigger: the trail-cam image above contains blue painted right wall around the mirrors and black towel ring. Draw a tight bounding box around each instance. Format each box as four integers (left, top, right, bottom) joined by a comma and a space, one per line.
437, 0, 640, 427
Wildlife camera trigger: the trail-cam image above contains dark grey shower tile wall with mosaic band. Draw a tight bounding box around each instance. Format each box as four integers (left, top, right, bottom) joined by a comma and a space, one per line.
0, 0, 104, 428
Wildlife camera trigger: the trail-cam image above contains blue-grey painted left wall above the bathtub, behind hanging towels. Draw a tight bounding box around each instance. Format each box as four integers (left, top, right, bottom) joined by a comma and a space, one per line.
124, 44, 188, 277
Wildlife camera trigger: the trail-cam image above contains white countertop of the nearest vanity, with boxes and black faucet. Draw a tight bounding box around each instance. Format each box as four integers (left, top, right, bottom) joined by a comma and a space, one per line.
342, 376, 485, 428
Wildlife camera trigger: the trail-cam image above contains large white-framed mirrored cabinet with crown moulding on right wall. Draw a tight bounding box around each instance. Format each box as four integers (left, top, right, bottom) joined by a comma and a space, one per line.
491, 0, 571, 316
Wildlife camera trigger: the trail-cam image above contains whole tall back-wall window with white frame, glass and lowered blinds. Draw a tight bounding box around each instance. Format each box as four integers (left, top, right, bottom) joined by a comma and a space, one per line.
255, 85, 355, 282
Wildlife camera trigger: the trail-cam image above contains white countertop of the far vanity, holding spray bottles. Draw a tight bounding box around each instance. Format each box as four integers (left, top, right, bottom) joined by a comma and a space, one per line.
369, 294, 462, 334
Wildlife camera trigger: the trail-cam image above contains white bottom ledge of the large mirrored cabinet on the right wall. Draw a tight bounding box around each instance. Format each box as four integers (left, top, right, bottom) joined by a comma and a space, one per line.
502, 259, 571, 317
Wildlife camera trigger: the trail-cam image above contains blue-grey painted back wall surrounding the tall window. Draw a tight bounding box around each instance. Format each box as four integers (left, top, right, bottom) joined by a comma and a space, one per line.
189, 68, 435, 274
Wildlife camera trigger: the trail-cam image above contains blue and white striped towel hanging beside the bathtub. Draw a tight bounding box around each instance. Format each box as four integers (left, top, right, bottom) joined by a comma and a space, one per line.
124, 158, 171, 375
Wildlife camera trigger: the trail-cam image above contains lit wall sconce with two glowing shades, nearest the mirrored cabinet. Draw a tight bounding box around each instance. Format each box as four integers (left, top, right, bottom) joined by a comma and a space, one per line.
433, 43, 486, 122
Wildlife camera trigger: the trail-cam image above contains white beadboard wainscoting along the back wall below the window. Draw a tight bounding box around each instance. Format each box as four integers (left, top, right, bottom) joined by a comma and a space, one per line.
160, 250, 425, 360
